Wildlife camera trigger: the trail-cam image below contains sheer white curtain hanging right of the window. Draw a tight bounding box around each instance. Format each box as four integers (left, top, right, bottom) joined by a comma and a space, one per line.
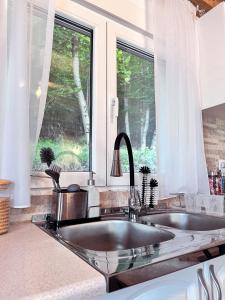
153, 0, 209, 196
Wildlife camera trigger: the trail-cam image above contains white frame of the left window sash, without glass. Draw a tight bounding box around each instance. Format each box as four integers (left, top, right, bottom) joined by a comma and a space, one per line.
31, 0, 106, 189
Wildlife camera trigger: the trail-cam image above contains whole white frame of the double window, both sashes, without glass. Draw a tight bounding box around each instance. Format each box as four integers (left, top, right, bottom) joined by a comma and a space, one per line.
31, 0, 158, 190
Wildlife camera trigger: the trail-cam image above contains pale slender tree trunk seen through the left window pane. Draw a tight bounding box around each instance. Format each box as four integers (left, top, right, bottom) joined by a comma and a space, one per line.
72, 35, 90, 144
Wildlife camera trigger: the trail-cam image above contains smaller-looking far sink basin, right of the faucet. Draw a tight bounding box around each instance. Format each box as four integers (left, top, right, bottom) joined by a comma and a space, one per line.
141, 213, 225, 231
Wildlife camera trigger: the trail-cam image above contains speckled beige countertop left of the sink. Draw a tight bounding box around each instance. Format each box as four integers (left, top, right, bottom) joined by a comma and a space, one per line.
0, 223, 106, 300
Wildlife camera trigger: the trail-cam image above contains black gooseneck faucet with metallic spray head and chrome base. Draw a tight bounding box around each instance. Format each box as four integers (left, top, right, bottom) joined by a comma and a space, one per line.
111, 132, 141, 221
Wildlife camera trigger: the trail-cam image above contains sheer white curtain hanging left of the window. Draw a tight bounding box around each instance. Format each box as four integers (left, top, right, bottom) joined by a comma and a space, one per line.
0, 0, 55, 208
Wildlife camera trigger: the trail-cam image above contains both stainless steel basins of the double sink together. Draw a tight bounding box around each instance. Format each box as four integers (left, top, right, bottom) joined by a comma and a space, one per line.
59, 212, 225, 251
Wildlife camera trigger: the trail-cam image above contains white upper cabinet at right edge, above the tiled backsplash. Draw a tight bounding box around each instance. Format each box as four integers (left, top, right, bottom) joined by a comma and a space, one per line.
198, 2, 225, 109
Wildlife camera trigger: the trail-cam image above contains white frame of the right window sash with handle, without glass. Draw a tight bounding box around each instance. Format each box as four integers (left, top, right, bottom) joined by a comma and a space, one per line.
107, 21, 154, 186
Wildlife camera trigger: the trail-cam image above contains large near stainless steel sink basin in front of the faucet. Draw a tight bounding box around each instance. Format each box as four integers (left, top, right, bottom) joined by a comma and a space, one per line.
59, 220, 174, 251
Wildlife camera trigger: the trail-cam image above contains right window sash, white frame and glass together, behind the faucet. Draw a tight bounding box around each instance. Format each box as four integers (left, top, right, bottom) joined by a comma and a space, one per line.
107, 22, 157, 186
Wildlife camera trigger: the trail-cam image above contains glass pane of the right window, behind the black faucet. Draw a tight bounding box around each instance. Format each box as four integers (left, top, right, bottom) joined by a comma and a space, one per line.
117, 43, 156, 172
